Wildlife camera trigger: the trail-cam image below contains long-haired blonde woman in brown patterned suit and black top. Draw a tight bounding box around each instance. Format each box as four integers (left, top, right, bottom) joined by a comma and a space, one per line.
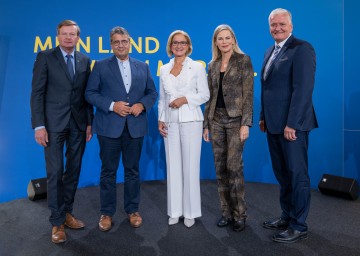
203, 25, 254, 231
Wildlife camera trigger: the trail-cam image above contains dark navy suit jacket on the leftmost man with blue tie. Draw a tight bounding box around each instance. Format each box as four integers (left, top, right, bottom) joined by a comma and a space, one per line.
30, 46, 93, 132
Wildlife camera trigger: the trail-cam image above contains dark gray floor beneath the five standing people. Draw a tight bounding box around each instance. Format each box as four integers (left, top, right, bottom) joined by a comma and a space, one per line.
0, 181, 360, 256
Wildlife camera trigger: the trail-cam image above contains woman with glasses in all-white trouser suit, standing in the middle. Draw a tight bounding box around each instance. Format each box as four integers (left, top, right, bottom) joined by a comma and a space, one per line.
158, 30, 210, 228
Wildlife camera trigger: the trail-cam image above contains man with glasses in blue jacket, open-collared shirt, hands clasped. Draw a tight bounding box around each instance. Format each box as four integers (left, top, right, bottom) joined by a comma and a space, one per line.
85, 27, 157, 231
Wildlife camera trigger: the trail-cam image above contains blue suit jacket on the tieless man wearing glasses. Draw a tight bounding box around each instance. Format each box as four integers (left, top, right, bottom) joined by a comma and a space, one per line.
85, 55, 157, 138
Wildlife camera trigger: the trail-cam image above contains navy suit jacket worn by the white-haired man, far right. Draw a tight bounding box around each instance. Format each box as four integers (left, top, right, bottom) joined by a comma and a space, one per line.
260, 36, 318, 134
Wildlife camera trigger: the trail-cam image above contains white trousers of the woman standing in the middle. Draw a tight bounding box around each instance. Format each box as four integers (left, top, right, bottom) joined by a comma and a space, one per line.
164, 122, 203, 219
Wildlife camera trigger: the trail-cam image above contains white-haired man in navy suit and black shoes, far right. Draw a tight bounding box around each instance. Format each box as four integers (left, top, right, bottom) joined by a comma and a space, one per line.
259, 8, 318, 243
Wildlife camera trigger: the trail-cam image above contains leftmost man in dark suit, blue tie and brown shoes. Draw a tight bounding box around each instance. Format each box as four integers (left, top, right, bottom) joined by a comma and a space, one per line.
30, 20, 93, 243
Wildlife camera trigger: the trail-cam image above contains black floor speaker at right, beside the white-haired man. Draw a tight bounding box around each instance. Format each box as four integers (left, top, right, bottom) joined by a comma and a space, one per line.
318, 174, 359, 200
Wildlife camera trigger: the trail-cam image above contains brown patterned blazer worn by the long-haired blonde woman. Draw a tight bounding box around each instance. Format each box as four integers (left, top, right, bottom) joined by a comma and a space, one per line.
204, 52, 254, 129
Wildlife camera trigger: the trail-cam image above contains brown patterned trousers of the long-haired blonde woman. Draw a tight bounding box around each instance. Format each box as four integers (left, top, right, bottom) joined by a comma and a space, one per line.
210, 108, 246, 220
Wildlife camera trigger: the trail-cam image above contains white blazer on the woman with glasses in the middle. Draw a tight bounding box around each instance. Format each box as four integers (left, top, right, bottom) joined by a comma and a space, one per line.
158, 57, 210, 123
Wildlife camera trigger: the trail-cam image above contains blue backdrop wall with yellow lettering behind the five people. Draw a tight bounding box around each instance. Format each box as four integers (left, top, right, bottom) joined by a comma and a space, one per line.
0, 0, 360, 202
